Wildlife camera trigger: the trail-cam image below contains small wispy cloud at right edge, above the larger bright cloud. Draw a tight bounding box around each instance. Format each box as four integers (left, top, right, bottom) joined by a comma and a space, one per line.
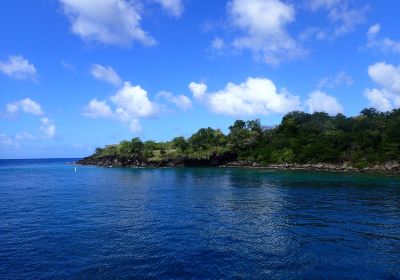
367, 24, 400, 54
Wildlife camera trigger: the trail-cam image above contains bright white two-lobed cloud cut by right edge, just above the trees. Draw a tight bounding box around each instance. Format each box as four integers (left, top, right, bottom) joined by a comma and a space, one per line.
364, 62, 400, 111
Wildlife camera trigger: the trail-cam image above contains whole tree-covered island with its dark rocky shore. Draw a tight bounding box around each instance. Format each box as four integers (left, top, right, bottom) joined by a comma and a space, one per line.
77, 108, 400, 173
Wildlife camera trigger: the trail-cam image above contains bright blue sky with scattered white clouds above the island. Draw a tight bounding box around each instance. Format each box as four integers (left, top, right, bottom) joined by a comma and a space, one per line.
0, 0, 400, 158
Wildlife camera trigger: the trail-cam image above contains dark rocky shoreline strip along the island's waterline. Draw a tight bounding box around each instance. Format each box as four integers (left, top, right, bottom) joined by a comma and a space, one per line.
76, 154, 400, 174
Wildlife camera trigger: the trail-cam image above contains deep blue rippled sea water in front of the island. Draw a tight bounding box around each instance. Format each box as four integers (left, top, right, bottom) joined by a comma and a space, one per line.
0, 160, 400, 279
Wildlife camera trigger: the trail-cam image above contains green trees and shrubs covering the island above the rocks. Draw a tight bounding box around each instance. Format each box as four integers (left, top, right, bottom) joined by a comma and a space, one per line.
94, 109, 400, 168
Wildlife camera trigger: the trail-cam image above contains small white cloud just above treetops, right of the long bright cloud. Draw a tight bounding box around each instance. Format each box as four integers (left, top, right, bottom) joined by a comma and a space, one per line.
306, 90, 344, 115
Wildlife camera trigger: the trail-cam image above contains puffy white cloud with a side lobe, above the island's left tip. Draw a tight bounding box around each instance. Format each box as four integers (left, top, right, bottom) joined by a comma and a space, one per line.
83, 82, 160, 133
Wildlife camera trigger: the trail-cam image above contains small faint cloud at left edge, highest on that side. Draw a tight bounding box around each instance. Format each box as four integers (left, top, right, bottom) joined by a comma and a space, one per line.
0, 55, 37, 81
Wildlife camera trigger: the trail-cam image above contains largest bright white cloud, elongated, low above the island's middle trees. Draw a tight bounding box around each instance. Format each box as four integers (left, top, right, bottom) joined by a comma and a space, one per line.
189, 78, 300, 116
